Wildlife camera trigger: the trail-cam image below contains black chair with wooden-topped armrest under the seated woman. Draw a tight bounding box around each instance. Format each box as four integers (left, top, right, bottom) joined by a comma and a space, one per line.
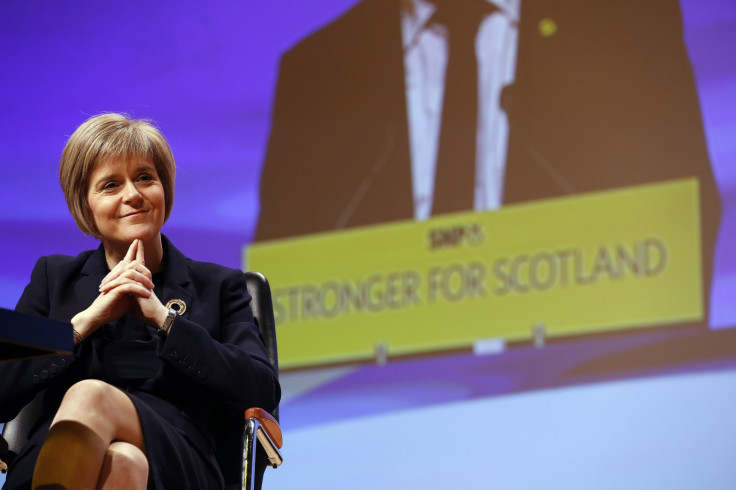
0, 272, 283, 490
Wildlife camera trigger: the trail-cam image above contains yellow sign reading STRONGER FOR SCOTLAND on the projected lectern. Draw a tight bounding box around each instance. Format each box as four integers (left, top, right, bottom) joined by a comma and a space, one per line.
244, 179, 703, 368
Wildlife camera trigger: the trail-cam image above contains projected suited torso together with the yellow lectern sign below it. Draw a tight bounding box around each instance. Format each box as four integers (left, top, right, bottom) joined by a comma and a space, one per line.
245, 0, 721, 363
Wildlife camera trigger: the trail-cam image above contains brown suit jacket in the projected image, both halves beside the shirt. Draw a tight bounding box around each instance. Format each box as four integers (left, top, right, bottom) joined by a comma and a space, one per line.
256, 0, 720, 318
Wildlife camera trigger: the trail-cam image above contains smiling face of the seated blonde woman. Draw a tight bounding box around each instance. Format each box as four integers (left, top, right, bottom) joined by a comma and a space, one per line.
87, 157, 166, 247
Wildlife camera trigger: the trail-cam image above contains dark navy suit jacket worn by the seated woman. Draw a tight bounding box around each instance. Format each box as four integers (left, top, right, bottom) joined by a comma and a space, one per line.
0, 238, 280, 486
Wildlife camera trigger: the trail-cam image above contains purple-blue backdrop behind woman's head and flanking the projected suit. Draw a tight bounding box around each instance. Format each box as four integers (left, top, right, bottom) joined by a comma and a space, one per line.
0, 0, 736, 326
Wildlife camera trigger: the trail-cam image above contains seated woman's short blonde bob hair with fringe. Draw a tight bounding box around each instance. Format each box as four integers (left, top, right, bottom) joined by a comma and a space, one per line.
59, 113, 176, 238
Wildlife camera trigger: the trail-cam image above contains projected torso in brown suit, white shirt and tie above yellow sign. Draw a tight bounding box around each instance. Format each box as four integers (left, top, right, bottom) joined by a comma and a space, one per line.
256, 0, 720, 241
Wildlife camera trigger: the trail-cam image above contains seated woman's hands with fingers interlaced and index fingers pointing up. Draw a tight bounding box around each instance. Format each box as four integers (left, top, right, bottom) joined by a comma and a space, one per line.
72, 239, 168, 338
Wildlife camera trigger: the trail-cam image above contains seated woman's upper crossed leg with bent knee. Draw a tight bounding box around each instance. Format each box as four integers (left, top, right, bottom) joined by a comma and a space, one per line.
33, 379, 147, 489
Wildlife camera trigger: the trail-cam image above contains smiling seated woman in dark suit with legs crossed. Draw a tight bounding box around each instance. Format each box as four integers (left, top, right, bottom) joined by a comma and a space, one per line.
0, 114, 280, 489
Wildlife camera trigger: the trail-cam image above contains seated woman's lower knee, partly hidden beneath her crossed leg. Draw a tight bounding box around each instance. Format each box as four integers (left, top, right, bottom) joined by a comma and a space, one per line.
97, 442, 148, 490
